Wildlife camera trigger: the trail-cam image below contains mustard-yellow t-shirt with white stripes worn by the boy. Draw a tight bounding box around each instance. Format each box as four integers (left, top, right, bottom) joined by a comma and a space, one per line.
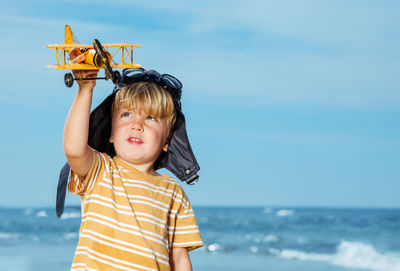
68, 152, 203, 270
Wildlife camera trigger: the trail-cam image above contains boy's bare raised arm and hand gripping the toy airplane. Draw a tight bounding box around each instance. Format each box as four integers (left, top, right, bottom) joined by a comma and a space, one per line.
63, 70, 98, 177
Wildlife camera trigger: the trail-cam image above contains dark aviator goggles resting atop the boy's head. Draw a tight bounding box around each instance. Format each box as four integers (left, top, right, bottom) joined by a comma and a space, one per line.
114, 68, 182, 108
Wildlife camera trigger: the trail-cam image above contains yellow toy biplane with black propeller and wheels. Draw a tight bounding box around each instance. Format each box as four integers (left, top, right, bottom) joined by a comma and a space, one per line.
46, 25, 142, 87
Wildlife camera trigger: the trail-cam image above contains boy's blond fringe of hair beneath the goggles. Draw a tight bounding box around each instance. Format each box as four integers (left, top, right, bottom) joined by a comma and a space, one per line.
112, 81, 176, 137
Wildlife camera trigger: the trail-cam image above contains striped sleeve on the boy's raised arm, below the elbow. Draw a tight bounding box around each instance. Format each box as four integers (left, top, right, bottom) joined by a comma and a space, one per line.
68, 151, 102, 196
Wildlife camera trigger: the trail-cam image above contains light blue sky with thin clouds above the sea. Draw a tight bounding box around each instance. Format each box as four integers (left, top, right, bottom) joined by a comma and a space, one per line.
0, 0, 400, 208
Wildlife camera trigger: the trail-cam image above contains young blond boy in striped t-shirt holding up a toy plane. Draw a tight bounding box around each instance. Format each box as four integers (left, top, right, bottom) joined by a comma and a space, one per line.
63, 66, 203, 270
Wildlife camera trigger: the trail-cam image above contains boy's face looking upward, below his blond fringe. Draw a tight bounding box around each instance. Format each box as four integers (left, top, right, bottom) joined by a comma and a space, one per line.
110, 108, 168, 166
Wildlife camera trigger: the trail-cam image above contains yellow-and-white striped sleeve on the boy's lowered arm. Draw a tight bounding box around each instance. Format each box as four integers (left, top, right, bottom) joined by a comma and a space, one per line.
172, 192, 203, 251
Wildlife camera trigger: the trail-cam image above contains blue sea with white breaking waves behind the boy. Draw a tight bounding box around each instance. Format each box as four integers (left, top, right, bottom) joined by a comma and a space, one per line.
0, 206, 400, 271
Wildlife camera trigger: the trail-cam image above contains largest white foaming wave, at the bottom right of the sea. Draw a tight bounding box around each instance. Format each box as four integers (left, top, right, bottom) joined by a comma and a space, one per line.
269, 241, 400, 271
